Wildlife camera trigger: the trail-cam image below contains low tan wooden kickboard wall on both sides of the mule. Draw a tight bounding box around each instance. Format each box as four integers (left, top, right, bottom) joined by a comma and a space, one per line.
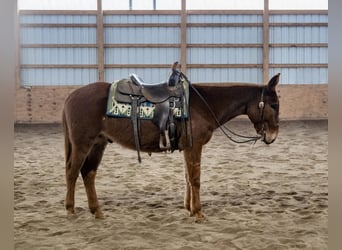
15, 84, 328, 123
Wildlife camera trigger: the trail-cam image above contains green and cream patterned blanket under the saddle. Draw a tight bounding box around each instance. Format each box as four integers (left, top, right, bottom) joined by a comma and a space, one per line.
106, 80, 189, 120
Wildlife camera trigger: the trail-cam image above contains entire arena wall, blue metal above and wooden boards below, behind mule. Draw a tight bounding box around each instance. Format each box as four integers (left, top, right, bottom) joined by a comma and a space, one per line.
15, 5, 328, 123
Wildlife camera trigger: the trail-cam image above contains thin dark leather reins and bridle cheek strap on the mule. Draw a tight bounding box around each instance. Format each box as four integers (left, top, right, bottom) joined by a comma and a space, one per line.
188, 81, 265, 143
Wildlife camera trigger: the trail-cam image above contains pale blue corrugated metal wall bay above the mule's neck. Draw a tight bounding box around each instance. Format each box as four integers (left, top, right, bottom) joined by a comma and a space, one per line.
187, 14, 263, 83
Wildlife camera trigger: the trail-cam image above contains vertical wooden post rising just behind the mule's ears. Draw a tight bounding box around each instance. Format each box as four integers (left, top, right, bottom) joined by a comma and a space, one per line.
263, 0, 270, 84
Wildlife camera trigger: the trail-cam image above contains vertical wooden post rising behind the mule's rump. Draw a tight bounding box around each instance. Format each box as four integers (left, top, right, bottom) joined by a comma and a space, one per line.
96, 0, 104, 82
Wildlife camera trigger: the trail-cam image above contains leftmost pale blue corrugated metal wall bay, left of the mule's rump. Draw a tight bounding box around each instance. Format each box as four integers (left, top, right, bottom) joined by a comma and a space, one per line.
19, 14, 98, 86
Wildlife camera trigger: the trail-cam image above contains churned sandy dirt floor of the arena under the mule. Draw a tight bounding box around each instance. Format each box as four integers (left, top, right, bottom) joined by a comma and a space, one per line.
14, 120, 328, 250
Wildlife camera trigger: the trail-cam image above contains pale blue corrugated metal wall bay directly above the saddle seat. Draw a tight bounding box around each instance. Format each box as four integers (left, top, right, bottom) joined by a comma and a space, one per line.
103, 14, 181, 82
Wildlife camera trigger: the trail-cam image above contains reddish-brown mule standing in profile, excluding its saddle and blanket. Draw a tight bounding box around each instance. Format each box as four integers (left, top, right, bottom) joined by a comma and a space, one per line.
63, 64, 280, 220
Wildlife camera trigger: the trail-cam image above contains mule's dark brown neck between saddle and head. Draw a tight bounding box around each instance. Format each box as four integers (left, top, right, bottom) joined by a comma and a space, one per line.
194, 84, 262, 128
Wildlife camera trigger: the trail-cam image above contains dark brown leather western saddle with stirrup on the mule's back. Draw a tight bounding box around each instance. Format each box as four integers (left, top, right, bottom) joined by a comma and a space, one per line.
115, 62, 185, 163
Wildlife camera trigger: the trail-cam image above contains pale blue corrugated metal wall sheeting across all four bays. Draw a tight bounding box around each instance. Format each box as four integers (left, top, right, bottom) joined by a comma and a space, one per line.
19, 11, 328, 86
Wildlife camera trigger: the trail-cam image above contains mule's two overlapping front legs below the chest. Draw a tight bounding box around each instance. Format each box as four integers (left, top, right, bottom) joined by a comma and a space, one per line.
184, 146, 204, 221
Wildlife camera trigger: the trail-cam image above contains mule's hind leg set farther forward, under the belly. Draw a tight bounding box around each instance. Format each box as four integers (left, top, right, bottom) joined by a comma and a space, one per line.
81, 142, 107, 218
